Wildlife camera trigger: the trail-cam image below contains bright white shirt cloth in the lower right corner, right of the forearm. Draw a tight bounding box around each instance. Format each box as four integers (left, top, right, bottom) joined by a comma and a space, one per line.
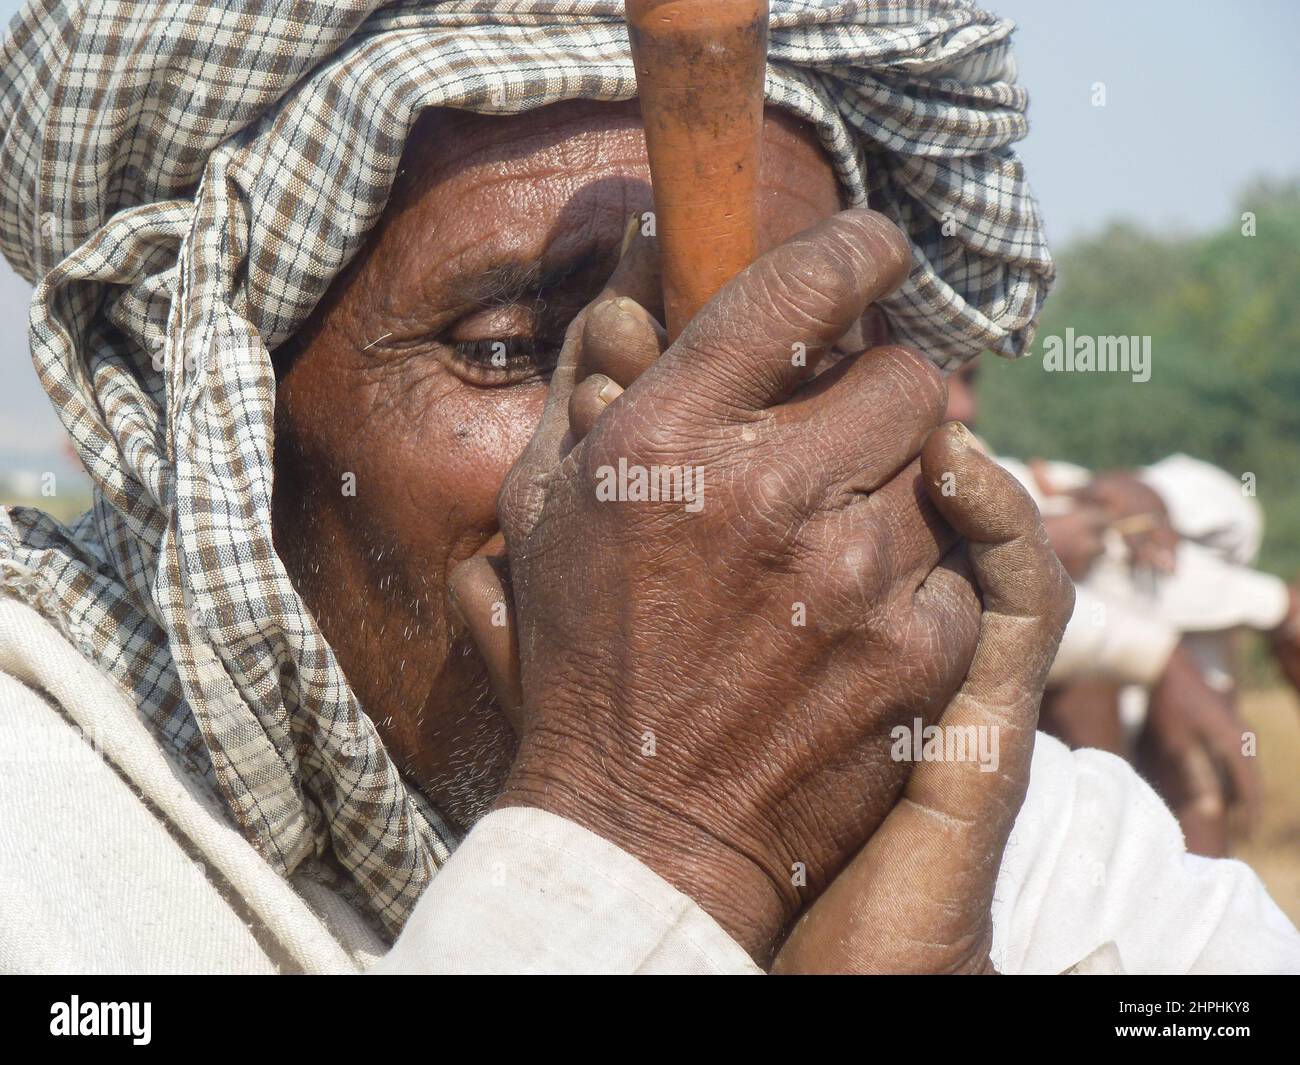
993, 733, 1300, 974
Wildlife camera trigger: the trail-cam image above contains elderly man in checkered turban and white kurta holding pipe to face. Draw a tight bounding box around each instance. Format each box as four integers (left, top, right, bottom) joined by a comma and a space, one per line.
0, 0, 1300, 973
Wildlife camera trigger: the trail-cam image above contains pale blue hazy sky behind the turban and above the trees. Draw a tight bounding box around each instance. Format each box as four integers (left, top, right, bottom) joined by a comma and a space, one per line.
0, 0, 1300, 483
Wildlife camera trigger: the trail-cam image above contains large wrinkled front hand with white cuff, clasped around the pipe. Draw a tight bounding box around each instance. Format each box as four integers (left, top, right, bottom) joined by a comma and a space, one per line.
498, 211, 980, 962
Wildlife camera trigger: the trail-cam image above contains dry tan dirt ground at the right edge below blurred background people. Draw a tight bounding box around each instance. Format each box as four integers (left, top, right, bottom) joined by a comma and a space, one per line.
1232, 688, 1300, 925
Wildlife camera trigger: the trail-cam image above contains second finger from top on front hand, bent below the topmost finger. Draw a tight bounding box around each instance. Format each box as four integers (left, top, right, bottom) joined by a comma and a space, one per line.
775, 346, 948, 492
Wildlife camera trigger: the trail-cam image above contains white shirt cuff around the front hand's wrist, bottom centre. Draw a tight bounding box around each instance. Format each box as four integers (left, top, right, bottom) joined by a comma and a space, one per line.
372, 808, 762, 974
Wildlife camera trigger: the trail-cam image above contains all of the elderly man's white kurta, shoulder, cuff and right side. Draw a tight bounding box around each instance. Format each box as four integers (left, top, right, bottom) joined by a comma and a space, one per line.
0, 597, 1300, 973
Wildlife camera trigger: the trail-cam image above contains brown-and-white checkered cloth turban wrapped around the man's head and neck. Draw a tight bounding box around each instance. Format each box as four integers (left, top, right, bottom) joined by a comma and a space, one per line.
0, 0, 1052, 932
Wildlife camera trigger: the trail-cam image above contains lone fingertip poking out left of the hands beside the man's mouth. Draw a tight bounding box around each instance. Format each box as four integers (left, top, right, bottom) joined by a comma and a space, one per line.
447, 533, 524, 733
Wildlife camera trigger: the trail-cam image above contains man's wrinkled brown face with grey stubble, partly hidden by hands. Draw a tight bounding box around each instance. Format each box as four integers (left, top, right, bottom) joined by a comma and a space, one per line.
274, 101, 841, 827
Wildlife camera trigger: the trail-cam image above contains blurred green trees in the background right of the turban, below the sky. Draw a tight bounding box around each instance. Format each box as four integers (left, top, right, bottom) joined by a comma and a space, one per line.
980, 182, 1300, 579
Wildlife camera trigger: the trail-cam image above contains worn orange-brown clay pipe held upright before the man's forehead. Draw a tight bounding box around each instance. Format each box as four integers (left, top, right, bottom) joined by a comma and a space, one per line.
627, 0, 767, 341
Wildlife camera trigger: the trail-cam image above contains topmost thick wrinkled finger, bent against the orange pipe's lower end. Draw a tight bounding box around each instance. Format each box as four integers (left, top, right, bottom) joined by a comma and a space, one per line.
646, 209, 911, 411
